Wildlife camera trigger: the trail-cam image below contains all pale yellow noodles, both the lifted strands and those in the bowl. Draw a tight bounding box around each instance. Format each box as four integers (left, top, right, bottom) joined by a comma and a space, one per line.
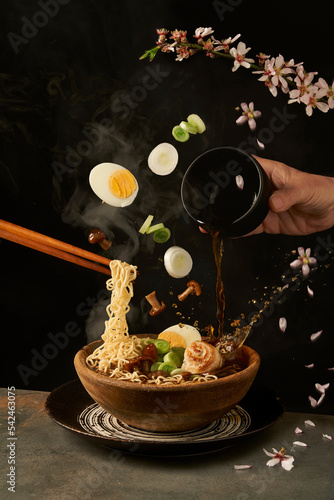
86, 260, 243, 385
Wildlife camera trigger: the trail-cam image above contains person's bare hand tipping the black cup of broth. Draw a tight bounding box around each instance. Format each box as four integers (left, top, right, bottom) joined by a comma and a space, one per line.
247, 156, 334, 236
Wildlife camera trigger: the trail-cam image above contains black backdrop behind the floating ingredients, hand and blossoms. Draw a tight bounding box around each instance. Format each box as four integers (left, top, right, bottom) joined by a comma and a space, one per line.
0, 0, 334, 413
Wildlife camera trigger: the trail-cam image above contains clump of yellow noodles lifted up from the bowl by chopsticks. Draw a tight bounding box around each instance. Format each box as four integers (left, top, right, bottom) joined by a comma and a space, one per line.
86, 260, 141, 378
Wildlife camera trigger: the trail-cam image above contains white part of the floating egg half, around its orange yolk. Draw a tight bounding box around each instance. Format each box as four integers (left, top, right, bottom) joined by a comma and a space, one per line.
89, 162, 139, 207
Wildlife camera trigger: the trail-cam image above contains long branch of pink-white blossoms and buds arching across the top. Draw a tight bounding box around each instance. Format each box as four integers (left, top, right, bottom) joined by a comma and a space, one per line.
140, 28, 334, 116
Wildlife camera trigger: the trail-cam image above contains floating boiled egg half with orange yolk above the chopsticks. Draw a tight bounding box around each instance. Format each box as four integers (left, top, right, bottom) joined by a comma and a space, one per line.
89, 163, 139, 207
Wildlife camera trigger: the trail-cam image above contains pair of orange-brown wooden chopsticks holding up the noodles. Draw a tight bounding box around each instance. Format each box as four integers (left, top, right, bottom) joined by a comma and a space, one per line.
0, 219, 110, 276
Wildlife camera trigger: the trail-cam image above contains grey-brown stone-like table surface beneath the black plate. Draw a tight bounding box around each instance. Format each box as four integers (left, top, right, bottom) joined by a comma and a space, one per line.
0, 388, 334, 500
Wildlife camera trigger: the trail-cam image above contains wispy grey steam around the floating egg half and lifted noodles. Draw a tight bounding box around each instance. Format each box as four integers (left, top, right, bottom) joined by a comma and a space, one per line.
57, 120, 183, 342
